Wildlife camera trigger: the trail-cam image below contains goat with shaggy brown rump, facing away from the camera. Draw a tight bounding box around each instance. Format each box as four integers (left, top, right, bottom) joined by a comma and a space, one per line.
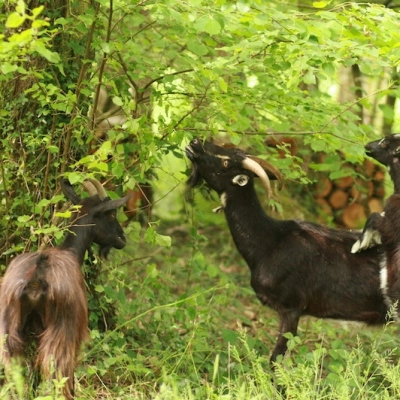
0, 180, 129, 399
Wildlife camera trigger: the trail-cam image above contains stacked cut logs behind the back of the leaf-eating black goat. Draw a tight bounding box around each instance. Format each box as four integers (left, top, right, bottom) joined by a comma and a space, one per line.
267, 138, 385, 229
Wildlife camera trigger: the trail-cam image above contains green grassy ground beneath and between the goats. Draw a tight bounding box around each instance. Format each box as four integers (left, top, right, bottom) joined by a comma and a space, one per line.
0, 220, 400, 400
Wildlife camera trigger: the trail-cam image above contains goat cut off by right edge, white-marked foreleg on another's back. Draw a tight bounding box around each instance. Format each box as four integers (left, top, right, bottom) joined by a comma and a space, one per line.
352, 134, 400, 314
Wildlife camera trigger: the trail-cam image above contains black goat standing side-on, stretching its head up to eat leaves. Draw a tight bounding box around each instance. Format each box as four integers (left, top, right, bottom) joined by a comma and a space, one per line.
186, 139, 388, 361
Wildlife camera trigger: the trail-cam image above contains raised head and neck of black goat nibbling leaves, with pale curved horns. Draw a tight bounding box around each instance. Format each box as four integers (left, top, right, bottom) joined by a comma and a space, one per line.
186, 138, 282, 268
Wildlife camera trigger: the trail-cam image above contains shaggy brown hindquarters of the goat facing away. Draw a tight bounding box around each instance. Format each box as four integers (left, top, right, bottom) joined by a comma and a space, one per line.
0, 248, 88, 399
